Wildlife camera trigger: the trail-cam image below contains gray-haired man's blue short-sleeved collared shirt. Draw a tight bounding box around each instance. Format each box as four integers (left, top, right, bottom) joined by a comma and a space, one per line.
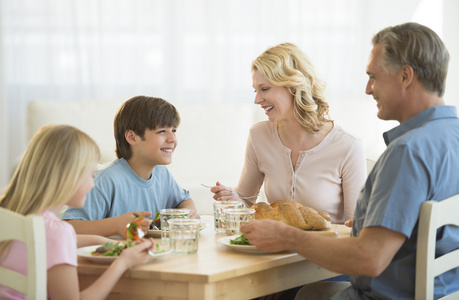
332, 106, 459, 299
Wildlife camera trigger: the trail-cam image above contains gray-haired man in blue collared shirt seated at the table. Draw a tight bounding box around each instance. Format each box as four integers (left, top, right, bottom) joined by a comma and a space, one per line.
241, 23, 459, 299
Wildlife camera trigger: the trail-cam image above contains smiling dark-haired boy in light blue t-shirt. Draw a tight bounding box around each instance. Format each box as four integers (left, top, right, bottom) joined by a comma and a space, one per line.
62, 96, 199, 236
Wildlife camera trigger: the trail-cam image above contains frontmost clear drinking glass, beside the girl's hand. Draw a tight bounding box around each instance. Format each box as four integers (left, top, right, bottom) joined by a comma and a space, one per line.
167, 219, 201, 254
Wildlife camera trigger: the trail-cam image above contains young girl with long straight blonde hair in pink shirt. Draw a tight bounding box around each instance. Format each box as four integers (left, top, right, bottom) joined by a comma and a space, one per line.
0, 125, 155, 300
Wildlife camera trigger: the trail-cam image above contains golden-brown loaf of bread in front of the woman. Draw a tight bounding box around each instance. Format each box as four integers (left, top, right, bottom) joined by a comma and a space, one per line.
252, 199, 331, 229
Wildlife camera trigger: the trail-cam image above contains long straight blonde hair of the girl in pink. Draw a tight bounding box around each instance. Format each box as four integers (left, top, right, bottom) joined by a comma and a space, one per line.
0, 125, 100, 253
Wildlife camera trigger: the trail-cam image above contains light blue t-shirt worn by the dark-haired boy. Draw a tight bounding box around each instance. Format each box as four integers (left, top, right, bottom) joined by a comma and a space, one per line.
62, 158, 190, 220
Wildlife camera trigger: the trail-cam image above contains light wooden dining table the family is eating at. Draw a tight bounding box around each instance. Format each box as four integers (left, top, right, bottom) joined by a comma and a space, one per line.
78, 215, 350, 300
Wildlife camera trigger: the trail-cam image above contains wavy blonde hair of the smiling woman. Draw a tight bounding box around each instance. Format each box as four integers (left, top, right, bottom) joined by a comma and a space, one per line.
252, 43, 331, 133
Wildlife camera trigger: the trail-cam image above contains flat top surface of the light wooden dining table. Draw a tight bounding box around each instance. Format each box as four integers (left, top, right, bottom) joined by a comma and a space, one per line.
78, 216, 350, 299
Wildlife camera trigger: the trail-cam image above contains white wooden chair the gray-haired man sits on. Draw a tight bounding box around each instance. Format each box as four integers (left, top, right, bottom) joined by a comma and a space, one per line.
415, 194, 459, 300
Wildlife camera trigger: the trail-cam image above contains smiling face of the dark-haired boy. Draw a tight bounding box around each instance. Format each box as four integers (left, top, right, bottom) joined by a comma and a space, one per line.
133, 127, 177, 166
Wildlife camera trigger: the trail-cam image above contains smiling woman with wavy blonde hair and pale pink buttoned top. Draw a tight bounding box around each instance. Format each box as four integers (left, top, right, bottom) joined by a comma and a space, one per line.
211, 43, 366, 224
